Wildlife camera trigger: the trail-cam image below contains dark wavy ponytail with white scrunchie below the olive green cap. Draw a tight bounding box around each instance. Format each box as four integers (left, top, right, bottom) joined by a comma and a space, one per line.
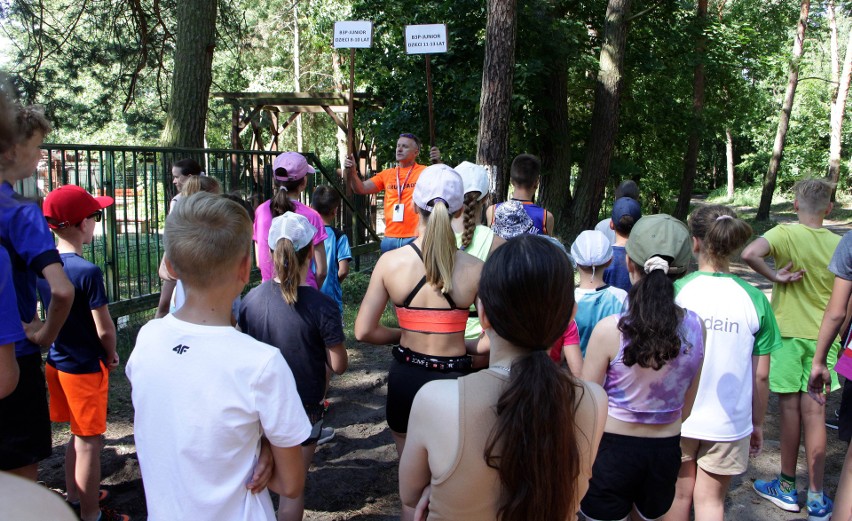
618, 256, 683, 370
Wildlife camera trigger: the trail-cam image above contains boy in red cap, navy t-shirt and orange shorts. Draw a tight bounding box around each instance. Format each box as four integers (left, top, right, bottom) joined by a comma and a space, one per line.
39, 185, 130, 521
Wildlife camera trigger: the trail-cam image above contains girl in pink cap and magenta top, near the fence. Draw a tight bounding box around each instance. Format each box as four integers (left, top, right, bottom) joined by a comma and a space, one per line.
252, 152, 328, 288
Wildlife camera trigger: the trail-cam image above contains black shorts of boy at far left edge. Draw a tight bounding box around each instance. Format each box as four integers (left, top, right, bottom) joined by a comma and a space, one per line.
0, 353, 53, 470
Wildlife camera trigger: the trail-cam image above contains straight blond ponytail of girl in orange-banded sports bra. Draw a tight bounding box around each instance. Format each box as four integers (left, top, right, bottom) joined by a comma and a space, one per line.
420, 200, 458, 294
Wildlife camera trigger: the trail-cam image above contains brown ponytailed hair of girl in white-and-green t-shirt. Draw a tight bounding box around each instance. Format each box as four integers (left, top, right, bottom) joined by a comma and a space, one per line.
689, 204, 753, 265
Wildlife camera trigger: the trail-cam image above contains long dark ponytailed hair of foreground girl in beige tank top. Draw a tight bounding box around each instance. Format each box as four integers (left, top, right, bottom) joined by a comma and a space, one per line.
479, 235, 582, 521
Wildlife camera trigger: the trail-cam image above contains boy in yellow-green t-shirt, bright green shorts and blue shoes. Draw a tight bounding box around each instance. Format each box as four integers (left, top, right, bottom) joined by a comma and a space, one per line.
742, 179, 840, 521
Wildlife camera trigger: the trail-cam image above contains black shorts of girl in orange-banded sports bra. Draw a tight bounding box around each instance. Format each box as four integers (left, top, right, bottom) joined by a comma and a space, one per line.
386, 356, 470, 434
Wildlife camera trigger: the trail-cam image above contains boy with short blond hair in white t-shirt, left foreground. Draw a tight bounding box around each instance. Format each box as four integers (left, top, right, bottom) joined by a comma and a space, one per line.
126, 193, 311, 521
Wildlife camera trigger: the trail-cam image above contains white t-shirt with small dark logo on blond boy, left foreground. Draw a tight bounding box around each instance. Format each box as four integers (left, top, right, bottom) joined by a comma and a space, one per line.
126, 315, 311, 521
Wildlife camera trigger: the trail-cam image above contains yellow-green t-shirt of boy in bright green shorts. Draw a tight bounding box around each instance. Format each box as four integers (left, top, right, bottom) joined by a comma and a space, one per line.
763, 223, 840, 340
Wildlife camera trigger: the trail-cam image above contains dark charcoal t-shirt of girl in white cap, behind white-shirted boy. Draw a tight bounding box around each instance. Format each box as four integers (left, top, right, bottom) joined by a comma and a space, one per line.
239, 279, 346, 405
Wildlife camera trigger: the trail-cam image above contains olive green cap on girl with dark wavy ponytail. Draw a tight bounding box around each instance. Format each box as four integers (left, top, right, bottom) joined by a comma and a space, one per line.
626, 213, 692, 274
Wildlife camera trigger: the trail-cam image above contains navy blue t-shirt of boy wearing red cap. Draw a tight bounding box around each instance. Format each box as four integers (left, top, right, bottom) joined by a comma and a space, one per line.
38, 253, 109, 374
